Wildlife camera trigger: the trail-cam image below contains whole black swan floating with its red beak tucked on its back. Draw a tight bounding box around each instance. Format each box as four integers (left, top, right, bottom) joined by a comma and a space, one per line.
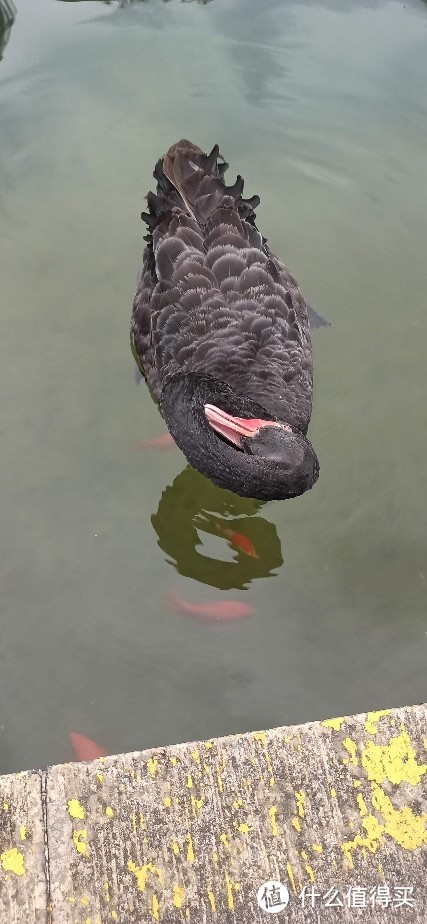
131, 140, 319, 501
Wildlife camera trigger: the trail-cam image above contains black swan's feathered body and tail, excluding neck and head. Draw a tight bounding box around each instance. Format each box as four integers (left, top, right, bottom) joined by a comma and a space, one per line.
132, 140, 312, 433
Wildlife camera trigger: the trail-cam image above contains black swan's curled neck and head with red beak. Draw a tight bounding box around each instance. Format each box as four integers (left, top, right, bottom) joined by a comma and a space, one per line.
161, 373, 319, 500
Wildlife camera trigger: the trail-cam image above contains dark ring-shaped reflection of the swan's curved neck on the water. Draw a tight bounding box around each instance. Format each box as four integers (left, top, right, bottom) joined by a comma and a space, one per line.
151, 466, 283, 590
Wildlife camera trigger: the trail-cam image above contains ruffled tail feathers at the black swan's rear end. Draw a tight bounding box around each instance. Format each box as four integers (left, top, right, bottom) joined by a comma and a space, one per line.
141, 139, 260, 239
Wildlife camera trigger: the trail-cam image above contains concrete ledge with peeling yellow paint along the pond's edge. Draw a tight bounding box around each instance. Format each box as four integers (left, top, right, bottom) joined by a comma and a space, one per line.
0, 706, 427, 924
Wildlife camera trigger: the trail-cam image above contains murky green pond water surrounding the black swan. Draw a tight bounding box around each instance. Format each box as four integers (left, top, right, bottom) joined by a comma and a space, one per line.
0, 0, 427, 772
